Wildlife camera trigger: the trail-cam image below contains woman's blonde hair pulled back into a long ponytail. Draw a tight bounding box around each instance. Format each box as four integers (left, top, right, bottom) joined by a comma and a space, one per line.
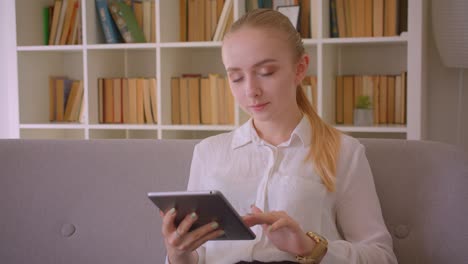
225, 9, 341, 192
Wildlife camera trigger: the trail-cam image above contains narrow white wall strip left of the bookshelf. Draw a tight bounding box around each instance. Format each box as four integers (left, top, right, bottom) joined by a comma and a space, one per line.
0, 0, 19, 138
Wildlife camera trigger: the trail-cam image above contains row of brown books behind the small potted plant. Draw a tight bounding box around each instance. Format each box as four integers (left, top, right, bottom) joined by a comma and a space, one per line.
336, 72, 407, 125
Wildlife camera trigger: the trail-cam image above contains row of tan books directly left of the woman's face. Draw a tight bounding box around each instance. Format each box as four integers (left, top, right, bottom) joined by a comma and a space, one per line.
171, 74, 234, 125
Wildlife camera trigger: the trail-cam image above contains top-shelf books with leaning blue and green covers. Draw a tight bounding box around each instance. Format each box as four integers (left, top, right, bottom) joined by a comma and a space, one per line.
95, 0, 156, 43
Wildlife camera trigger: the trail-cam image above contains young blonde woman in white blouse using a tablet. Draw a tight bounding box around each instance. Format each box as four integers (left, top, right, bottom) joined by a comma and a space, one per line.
161, 9, 397, 264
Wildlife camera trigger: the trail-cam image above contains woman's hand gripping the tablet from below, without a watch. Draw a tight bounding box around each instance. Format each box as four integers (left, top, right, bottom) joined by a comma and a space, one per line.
159, 208, 224, 264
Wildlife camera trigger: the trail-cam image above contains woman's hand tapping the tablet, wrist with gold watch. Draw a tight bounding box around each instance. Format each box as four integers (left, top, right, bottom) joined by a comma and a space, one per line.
243, 205, 315, 256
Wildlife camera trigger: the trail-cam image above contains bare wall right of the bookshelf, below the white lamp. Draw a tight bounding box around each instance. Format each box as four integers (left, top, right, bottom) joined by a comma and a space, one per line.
427, 2, 468, 151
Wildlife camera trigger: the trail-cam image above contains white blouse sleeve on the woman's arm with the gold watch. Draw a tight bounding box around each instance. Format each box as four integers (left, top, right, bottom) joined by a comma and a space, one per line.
321, 144, 397, 264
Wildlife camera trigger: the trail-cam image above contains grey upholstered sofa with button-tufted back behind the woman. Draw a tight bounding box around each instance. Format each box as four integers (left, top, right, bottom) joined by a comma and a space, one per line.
0, 139, 468, 264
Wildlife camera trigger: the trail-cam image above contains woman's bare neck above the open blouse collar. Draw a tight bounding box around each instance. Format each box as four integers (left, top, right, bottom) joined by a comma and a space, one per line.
253, 109, 303, 146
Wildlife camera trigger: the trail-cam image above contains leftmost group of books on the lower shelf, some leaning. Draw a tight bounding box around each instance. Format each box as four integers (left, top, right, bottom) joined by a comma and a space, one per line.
49, 76, 83, 122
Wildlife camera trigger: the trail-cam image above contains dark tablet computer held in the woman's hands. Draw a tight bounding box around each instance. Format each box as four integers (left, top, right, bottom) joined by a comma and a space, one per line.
148, 191, 255, 240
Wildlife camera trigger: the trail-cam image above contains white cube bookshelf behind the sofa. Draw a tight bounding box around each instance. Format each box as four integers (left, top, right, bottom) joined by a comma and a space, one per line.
0, 0, 427, 139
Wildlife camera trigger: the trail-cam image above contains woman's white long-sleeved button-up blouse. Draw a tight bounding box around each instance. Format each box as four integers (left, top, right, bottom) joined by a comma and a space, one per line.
188, 117, 397, 264
